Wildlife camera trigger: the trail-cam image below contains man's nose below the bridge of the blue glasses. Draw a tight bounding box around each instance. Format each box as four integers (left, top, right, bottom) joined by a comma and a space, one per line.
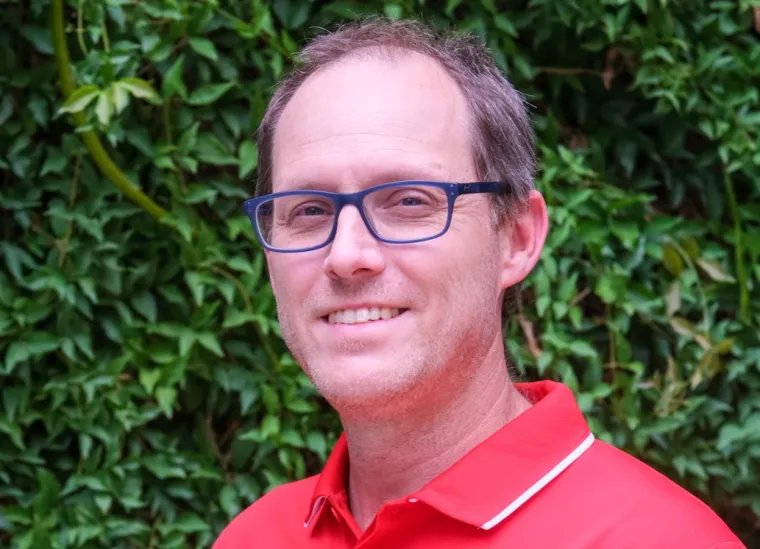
324, 206, 385, 281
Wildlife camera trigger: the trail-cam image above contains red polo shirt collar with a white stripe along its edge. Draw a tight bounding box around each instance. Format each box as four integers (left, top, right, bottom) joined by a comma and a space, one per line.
304, 381, 594, 530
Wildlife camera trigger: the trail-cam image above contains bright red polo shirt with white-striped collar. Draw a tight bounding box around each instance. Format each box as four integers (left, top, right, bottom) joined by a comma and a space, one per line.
214, 381, 744, 549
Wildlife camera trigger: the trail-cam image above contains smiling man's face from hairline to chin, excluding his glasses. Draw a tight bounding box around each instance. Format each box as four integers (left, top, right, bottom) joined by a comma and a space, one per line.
267, 54, 506, 412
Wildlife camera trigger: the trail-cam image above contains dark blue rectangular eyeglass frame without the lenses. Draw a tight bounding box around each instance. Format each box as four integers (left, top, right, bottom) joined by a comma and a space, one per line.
243, 180, 510, 253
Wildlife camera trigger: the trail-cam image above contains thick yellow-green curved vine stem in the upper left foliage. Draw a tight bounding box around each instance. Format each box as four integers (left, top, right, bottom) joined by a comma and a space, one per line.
50, 0, 166, 219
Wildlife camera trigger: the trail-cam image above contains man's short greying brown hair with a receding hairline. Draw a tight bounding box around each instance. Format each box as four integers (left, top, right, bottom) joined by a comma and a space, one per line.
256, 17, 536, 312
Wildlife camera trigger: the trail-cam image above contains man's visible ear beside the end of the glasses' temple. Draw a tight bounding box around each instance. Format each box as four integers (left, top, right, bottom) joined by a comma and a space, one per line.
501, 190, 549, 289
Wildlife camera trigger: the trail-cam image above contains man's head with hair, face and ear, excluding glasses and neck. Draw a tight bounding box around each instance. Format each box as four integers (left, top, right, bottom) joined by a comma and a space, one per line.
252, 20, 546, 411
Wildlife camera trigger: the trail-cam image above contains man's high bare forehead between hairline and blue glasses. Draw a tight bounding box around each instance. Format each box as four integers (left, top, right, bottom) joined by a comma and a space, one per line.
272, 53, 474, 191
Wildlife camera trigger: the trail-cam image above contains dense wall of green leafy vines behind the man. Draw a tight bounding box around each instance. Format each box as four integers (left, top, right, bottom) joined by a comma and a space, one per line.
0, 0, 760, 549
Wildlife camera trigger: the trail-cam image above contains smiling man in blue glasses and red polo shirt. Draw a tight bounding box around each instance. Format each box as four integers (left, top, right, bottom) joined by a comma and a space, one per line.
215, 19, 743, 549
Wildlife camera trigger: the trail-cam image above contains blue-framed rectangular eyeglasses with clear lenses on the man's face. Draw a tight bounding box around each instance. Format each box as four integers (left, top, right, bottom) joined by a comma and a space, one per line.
243, 181, 509, 253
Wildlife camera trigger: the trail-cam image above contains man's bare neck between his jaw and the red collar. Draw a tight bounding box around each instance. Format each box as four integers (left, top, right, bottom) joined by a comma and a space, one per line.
343, 345, 530, 530
